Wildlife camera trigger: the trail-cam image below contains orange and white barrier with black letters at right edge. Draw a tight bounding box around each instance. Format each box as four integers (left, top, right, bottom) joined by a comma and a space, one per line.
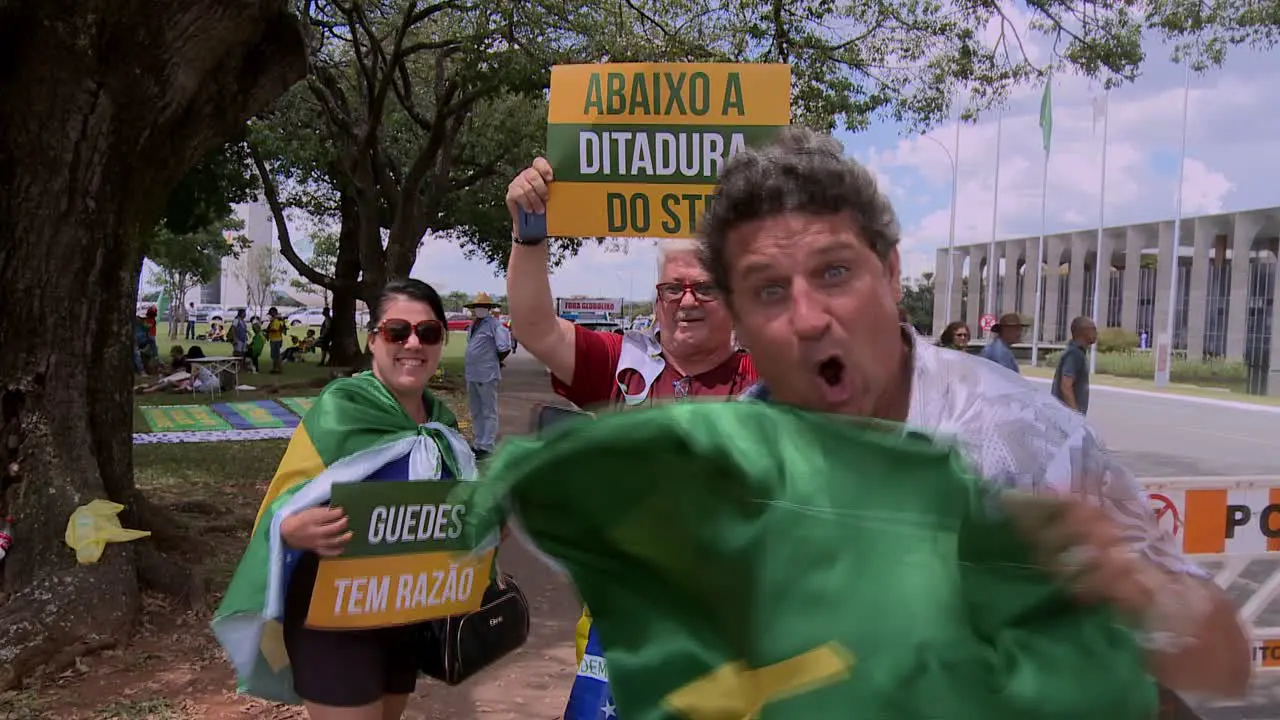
1140, 477, 1280, 670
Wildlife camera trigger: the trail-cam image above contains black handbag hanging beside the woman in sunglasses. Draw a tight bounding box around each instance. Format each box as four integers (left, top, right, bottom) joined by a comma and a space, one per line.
419, 570, 529, 685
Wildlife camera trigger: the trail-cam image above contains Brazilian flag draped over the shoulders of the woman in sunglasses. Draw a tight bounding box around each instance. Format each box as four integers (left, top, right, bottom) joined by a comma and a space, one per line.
212, 372, 489, 703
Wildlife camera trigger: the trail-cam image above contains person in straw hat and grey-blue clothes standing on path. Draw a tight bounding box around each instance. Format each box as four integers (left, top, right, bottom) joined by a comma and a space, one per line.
463, 292, 511, 457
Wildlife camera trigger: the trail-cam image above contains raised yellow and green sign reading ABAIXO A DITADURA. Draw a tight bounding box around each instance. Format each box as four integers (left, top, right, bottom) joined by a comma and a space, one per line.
547, 63, 791, 238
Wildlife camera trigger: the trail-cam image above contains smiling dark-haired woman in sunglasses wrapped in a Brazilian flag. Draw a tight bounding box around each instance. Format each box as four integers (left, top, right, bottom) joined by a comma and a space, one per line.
225, 279, 475, 720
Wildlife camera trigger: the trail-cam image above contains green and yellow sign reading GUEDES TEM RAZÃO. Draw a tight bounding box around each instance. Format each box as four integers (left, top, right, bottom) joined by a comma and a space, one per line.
307, 480, 494, 629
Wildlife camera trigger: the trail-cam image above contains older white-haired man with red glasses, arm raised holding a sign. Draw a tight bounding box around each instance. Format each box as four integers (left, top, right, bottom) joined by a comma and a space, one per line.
507, 158, 756, 407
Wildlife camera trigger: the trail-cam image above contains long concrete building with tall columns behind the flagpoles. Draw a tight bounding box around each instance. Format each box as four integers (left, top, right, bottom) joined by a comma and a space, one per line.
933, 202, 1280, 395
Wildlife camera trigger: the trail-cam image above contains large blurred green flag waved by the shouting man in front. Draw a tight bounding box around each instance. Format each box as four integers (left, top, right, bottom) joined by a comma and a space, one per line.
466, 402, 1156, 720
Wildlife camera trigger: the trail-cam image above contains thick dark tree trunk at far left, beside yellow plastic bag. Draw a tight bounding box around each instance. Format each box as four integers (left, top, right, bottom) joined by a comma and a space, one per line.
0, 0, 306, 691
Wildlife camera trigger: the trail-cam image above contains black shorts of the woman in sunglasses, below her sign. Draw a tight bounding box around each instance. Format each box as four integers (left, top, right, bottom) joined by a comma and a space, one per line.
284, 552, 420, 707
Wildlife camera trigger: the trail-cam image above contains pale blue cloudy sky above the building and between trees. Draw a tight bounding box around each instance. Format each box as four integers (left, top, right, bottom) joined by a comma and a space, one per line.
272, 11, 1280, 300
